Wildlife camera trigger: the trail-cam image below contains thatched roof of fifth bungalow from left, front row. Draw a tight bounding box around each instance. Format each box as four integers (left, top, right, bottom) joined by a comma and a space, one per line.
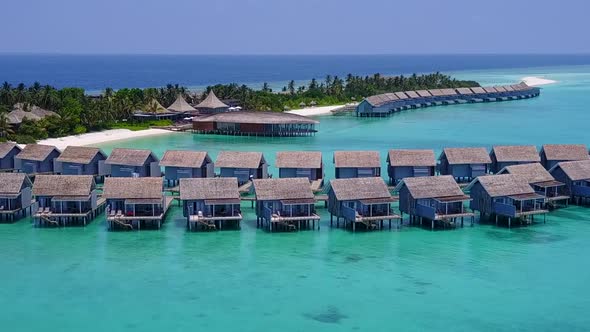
254, 178, 314, 201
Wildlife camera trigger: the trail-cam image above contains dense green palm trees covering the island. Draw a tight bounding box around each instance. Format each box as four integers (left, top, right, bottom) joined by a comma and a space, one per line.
0, 73, 479, 143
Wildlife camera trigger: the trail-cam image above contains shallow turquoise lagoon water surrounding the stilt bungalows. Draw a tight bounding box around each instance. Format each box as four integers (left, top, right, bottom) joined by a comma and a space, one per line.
0, 66, 590, 331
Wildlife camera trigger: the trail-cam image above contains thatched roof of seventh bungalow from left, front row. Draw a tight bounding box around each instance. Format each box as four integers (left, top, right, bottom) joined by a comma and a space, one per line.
395, 175, 465, 199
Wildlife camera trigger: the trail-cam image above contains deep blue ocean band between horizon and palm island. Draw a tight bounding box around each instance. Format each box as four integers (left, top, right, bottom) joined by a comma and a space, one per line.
0, 54, 590, 92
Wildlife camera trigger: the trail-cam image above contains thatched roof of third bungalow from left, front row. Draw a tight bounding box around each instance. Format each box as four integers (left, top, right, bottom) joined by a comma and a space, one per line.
103, 177, 164, 199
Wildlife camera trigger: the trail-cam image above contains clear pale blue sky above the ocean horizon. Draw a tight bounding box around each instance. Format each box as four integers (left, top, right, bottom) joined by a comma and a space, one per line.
0, 0, 590, 54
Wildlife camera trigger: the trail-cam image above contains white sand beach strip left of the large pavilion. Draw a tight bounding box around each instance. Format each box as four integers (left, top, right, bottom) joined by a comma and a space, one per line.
37, 129, 171, 150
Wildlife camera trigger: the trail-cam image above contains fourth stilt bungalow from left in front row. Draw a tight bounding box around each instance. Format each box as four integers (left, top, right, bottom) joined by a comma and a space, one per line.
180, 178, 242, 230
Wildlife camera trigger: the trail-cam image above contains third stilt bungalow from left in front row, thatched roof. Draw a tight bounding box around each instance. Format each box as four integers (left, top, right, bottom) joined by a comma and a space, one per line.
103, 177, 172, 230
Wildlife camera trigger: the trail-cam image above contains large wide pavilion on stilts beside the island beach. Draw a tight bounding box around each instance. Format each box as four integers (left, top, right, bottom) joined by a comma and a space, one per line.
193, 111, 319, 137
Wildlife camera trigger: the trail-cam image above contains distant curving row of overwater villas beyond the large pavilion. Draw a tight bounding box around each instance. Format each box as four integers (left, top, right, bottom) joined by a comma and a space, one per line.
356, 82, 541, 116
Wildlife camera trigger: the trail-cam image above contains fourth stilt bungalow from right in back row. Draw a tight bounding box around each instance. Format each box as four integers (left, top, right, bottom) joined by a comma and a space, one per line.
387, 149, 436, 185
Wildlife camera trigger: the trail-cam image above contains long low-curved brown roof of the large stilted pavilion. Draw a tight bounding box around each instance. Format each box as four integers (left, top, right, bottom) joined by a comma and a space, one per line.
193, 111, 319, 124
